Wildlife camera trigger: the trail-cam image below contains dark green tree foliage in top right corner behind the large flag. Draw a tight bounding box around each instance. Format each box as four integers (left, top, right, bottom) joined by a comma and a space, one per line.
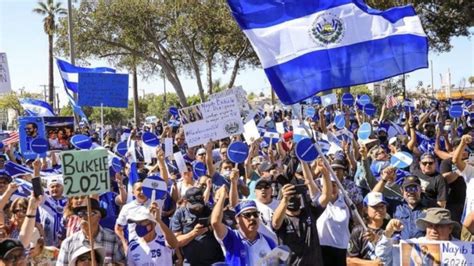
366, 0, 474, 52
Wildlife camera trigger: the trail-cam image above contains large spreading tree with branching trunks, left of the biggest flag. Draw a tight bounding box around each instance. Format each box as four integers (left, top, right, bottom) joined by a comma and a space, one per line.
57, 0, 258, 106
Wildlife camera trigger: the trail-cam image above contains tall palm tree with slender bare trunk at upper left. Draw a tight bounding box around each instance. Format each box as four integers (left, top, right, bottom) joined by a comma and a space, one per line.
33, 0, 67, 106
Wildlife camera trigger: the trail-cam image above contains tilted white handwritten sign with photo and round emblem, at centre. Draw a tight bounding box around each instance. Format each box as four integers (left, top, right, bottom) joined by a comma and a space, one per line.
179, 95, 244, 147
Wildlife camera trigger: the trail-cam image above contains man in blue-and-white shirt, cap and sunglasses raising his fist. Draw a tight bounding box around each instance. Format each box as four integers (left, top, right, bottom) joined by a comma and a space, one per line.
211, 186, 276, 266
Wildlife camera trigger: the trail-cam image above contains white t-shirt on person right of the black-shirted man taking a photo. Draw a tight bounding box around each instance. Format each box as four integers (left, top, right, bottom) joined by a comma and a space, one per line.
316, 194, 350, 249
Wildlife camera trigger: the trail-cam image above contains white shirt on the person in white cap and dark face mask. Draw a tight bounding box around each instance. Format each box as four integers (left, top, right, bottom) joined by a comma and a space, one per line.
127, 230, 173, 266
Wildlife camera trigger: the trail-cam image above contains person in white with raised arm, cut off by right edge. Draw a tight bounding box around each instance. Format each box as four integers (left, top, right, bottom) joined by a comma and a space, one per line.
453, 135, 474, 221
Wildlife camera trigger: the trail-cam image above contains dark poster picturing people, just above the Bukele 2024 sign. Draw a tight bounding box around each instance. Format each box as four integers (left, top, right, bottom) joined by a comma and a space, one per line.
43, 116, 74, 150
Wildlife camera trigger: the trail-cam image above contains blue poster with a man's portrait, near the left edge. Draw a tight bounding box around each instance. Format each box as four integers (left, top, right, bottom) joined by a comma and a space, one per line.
18, 116, 46, 159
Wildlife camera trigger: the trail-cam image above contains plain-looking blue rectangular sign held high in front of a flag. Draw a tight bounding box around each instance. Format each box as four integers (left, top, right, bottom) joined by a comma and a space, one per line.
78, 72, 128, 108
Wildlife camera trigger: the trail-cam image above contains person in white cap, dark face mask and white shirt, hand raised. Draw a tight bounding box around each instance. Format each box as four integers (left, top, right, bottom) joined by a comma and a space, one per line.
127, 202, 178, 266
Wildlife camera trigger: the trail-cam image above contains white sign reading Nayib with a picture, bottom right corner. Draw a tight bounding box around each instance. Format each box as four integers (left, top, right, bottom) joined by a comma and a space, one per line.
400, 240, 474, 266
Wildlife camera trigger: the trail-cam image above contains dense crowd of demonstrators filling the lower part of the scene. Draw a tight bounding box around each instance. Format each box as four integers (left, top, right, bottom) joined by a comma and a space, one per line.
0, 96, 474, 266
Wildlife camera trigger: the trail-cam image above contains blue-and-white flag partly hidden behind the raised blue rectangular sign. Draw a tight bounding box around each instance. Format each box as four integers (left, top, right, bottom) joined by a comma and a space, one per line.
56, 58, 115, 93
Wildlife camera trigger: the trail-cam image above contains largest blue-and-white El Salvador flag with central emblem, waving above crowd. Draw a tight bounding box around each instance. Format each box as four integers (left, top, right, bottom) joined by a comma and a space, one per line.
228, 0, 428, 104
